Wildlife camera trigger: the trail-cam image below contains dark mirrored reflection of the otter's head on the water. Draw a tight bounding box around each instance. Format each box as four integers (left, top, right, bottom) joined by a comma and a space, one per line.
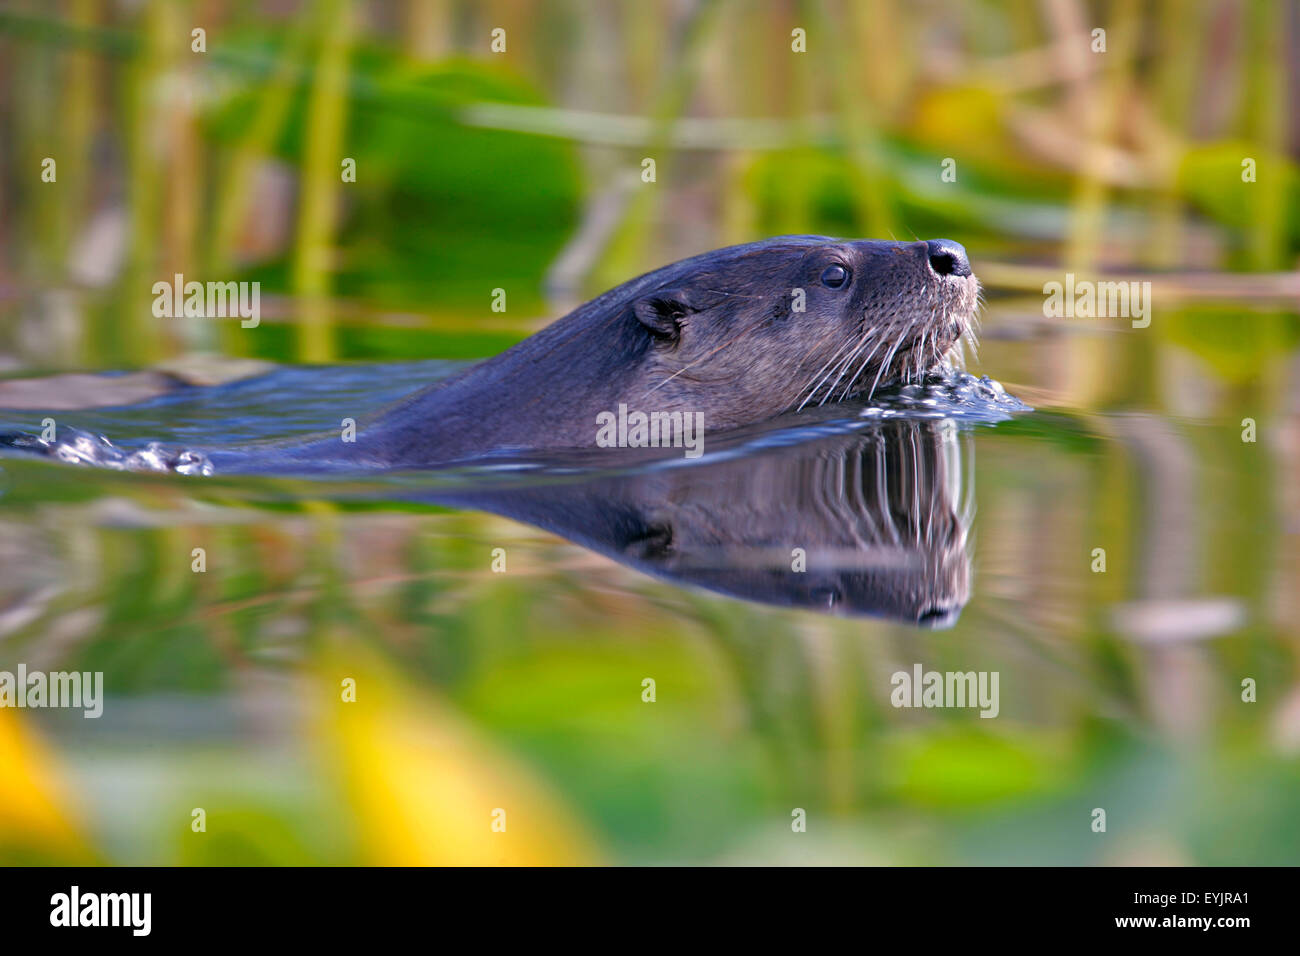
443, 420, 970, 627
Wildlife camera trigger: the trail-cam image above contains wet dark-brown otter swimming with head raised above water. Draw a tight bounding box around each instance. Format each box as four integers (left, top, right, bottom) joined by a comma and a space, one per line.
4, 235, 979, 473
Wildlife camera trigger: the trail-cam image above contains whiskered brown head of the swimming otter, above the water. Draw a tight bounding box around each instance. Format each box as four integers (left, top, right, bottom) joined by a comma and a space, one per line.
631, 237, 979, 428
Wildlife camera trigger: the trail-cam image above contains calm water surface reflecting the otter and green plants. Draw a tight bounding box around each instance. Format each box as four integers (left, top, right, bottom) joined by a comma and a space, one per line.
0, 329, 1300, 864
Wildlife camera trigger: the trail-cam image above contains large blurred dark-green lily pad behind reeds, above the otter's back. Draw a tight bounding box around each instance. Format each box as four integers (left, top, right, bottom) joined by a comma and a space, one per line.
207, 51, 580, 310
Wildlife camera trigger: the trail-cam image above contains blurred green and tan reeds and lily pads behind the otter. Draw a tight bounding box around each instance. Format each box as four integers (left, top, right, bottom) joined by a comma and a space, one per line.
0, 0, 1300, 367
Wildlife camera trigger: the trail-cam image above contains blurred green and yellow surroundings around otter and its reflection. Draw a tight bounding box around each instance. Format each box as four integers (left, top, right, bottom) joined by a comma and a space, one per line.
0, 0, 1300, 864
